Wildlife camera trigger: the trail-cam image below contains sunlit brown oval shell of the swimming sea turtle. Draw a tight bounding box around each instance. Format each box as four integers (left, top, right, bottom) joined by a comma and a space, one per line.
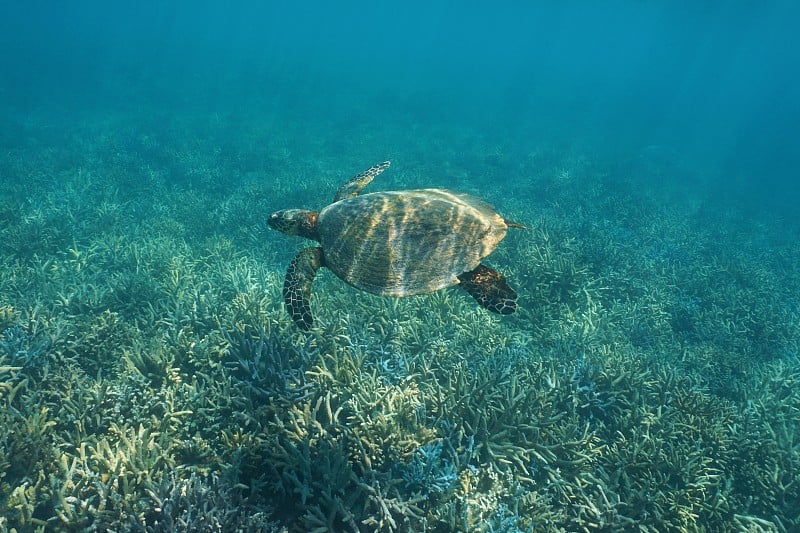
317, 189, 507, 296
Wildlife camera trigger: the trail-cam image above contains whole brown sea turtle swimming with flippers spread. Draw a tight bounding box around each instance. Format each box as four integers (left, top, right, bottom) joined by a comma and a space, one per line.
268, 161, 525, 330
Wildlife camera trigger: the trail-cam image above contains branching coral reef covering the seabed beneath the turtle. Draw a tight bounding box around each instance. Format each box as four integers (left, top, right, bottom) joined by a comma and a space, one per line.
0, 106, 800, 533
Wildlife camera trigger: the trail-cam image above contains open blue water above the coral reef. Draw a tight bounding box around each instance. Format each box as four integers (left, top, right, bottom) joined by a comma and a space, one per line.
0, 1, 800, 209
